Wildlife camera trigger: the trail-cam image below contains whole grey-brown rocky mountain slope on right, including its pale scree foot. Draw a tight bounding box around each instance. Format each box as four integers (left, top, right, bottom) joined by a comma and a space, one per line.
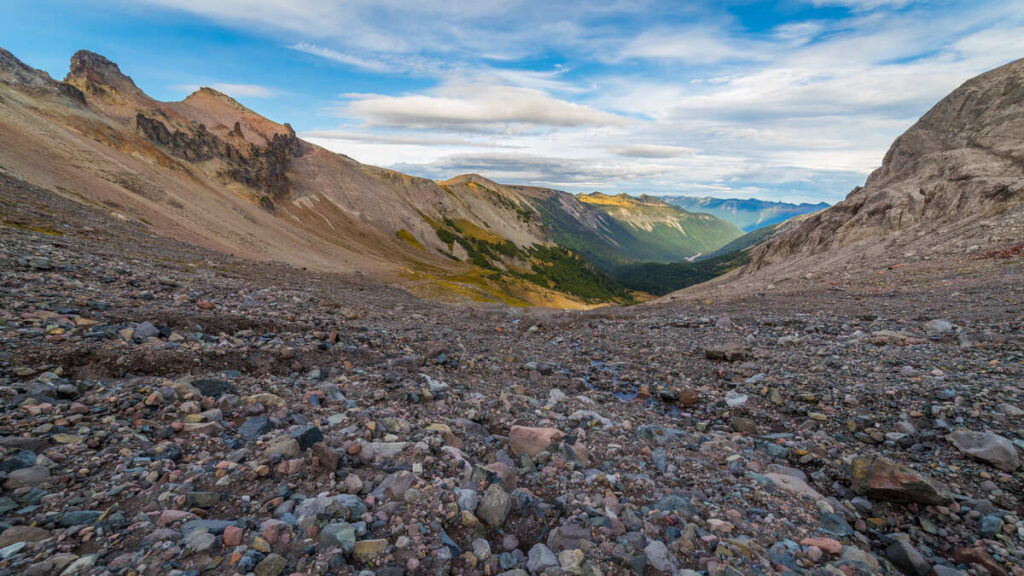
663, 59, 1024, 297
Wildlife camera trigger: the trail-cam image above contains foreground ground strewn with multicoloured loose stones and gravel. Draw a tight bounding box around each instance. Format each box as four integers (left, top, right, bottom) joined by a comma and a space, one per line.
0, 171, 1024, 576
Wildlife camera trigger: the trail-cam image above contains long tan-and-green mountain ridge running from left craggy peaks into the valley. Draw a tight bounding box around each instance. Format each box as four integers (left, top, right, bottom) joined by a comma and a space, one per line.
0, 49, 739, 307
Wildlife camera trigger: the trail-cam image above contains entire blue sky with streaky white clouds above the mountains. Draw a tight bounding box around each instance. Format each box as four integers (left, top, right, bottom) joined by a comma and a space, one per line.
0, 0, 1024, 203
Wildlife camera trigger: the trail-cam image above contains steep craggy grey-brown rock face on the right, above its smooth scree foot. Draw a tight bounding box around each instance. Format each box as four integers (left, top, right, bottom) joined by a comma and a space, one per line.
746, 59, 1024, 272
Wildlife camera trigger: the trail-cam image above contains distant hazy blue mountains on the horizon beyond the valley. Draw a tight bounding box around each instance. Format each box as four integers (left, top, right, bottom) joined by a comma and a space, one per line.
660, 196, 828, 232
